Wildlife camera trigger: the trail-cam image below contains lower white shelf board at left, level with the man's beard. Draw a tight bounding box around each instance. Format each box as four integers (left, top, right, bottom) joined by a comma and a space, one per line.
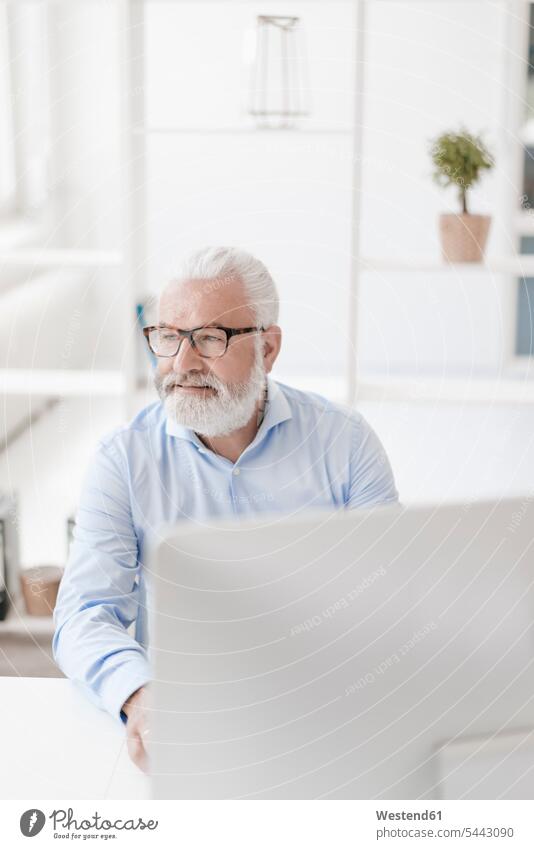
0, 368, 126, 397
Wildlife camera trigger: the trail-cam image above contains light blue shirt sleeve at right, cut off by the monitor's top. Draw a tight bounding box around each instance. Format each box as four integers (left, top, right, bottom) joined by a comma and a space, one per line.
345, 415, 399, 509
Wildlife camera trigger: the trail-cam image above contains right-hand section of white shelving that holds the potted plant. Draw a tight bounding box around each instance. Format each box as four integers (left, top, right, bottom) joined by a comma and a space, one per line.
347, 0, 534, 403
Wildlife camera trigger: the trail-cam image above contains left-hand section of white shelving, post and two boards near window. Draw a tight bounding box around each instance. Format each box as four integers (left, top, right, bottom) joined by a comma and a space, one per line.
0, 0, 145, 408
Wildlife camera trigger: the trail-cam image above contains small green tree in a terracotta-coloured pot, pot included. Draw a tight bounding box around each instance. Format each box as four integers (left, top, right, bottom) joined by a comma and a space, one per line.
430, 129, 494, 262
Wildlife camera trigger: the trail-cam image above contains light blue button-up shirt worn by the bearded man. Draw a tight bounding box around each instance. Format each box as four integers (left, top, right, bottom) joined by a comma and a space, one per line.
53, 378, 398, 720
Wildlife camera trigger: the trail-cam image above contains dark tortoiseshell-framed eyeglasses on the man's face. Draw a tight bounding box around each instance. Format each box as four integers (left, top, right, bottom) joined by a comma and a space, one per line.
143, 327, 264, 358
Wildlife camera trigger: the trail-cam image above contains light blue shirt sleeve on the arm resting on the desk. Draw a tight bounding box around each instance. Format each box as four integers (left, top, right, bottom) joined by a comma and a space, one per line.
52, 444, 150, 722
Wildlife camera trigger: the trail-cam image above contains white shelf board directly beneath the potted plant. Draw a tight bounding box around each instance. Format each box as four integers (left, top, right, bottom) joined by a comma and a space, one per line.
359, 254, 534, 277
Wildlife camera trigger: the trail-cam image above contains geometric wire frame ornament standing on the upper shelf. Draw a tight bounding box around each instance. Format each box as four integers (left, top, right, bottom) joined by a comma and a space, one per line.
249, 15, 309, 128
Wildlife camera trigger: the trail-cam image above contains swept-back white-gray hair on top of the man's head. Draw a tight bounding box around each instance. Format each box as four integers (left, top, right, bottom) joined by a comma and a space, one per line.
174, 247, 279, 327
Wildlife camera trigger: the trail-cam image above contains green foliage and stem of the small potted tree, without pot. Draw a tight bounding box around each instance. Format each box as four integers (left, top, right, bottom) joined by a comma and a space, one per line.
430, 128, 495, 214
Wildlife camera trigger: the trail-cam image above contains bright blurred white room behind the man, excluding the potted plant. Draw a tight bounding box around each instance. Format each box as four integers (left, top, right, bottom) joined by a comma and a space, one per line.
0, 0, 534, 675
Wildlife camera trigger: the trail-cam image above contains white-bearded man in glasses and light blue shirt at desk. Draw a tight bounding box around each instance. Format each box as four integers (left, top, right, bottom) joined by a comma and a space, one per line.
53, 243, 398, 769
